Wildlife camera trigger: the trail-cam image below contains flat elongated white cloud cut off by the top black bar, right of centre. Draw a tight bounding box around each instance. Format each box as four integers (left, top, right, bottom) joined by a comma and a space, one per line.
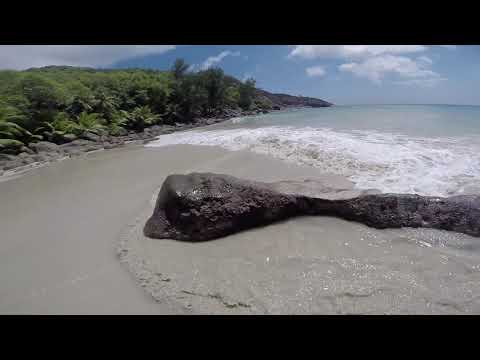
289, 45, 427, 59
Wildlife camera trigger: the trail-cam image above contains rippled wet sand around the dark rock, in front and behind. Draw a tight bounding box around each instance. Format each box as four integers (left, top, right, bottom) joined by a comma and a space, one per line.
117, 145, 480, 314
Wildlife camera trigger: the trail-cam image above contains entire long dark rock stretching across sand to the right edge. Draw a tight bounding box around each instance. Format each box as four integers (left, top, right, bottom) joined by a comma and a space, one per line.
144, 173, 480, 241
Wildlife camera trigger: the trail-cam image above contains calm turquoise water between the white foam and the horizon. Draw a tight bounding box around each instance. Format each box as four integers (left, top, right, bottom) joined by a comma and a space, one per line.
227, 105, 480, 136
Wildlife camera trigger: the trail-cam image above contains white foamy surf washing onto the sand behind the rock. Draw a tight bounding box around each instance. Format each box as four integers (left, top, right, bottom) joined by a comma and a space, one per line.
147, 126, 480, 196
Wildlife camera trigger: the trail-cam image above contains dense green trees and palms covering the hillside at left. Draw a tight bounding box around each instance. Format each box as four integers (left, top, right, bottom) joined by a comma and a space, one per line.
0, 59, 266, 150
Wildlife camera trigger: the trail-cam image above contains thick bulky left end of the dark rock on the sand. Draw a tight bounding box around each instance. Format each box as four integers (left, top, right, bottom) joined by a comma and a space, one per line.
144, 174, 297, 241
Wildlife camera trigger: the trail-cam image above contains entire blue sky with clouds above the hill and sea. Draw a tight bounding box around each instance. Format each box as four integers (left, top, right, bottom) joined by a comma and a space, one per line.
0, 45, 480, 105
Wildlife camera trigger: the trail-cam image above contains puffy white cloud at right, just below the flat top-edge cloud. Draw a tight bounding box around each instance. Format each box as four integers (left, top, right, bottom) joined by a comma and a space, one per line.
339, 55, 440, 84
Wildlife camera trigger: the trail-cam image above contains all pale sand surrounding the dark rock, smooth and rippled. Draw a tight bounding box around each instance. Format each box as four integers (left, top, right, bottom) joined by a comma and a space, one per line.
0, 145, 480, 314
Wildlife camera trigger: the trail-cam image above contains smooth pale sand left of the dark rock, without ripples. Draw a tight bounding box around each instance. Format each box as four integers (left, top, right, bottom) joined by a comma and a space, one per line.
0, 147, 230, 314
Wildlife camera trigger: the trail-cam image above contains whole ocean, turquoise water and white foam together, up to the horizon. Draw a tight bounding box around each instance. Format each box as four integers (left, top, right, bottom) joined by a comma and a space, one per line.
147, 105, 480, 196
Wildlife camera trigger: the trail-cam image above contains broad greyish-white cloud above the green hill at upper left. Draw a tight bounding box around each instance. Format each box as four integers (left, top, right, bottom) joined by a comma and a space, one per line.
0, 45, 175, 70
